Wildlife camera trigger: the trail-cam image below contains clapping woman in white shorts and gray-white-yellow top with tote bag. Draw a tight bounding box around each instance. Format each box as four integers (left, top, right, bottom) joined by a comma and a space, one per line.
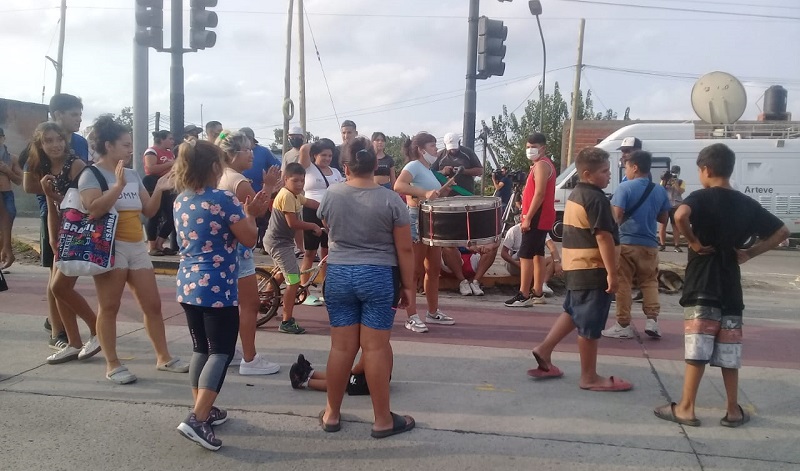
78, 115, 189, 384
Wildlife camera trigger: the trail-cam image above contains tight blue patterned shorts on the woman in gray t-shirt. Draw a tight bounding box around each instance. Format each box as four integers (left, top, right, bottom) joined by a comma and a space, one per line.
323, 265, 400, 330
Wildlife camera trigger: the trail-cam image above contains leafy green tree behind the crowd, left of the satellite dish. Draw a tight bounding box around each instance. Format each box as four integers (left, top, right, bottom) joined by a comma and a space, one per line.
489, 82, 630, 174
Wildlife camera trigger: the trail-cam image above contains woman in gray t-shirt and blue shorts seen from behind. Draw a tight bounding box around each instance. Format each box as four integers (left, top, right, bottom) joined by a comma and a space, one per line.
317, 139, 416, 438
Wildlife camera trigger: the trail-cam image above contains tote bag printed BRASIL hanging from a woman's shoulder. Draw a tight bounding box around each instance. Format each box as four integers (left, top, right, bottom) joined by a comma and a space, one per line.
55, 165, 119, 276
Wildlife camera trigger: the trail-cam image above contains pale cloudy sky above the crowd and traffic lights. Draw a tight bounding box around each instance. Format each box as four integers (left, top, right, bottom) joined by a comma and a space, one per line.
0, 0, 800, 148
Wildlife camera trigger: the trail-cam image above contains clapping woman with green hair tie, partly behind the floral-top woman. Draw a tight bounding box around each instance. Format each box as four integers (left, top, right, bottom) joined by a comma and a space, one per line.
216, 130, 281, 375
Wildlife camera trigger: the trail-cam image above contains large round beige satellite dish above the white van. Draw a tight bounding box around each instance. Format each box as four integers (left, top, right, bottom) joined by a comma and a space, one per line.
692, 72, 747, 124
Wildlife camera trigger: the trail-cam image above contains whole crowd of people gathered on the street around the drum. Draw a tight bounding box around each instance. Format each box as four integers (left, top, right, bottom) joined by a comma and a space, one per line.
0, 94, 788, 450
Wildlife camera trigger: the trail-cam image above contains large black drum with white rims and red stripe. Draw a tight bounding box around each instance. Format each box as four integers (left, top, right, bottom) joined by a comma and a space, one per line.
419, 196, 503, 247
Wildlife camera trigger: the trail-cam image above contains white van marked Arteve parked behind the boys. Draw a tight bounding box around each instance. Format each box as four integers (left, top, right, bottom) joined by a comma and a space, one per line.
551, 122, 800, 241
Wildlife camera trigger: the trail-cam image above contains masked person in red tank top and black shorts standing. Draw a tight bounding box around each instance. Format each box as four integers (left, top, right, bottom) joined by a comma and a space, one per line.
505, 133, 556, 307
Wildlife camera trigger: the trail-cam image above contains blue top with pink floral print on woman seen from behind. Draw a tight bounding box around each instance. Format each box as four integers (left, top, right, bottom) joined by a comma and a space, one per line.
173, 187, 245, 308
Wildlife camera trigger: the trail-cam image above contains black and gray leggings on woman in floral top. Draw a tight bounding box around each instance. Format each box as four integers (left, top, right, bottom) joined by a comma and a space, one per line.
181, 303, 239, 393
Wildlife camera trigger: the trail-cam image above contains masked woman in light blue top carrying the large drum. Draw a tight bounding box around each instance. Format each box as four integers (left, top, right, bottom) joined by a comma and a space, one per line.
394, 132, 455, 333
